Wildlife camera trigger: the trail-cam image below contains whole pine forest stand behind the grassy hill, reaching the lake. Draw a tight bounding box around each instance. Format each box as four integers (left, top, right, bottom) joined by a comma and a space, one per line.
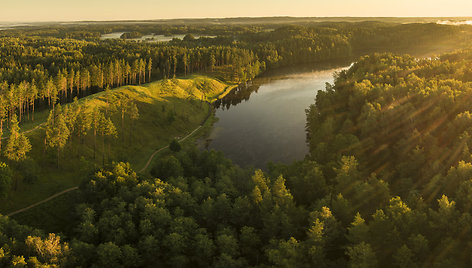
0, 37, 265, 131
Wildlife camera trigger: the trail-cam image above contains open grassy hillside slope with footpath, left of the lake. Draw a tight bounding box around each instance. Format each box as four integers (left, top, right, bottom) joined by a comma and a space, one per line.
0, 75, 236, 219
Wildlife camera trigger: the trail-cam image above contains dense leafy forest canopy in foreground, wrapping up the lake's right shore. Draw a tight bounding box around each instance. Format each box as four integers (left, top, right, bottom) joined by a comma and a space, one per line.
3, 51, 472, 267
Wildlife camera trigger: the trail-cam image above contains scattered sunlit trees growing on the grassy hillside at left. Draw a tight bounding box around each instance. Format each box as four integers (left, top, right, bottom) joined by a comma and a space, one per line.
0, 91, 140, 197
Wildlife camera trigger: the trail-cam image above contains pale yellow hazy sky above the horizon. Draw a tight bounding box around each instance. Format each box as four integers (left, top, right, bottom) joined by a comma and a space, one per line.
0, 0, 472, 21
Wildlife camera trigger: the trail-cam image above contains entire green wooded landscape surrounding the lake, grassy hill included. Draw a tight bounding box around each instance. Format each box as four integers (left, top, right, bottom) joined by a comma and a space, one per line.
0, 19, 472, 267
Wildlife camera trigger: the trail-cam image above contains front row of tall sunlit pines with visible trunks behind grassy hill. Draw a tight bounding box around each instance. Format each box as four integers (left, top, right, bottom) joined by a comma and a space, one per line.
0, 56, 152, 121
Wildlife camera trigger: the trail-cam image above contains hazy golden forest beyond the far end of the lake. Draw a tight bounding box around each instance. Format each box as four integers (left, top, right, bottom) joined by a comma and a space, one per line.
238, 22, 472, 67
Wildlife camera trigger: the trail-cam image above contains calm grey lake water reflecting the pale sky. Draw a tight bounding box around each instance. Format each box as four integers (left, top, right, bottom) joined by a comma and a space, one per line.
200, 63, 349, 168
